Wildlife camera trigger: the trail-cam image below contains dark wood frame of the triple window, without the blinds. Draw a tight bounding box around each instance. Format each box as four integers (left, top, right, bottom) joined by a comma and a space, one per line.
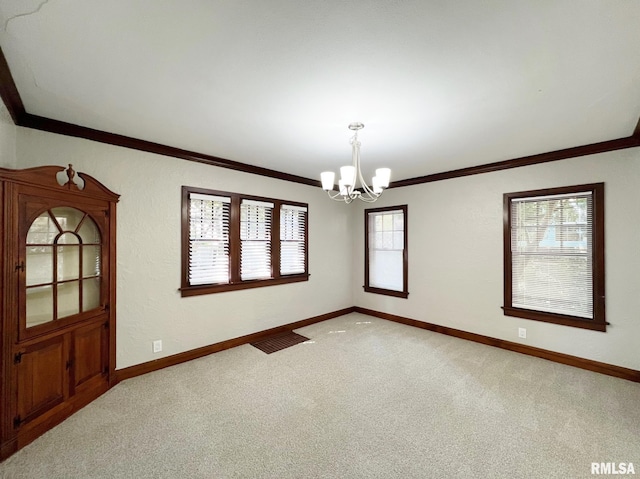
180, 186, 309, 297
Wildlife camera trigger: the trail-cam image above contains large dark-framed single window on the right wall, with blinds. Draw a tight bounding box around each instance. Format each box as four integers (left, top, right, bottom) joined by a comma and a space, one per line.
504, 183, 607, 331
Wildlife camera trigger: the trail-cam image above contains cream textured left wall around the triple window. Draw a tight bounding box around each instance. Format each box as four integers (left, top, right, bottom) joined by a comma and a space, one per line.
17, 128, 353, 369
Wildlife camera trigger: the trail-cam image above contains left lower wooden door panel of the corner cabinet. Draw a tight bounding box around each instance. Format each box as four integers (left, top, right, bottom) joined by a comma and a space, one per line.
16, 336, 69, 423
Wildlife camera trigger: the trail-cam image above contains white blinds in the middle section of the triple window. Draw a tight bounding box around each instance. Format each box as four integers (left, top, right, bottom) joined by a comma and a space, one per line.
240, 199, 273, 281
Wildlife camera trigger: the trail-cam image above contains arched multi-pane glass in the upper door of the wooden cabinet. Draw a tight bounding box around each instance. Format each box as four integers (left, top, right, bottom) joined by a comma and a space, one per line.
24, 206, 104, 331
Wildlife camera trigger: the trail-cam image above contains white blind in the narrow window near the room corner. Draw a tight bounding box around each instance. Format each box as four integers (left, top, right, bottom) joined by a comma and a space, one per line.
368, 210, 404, 291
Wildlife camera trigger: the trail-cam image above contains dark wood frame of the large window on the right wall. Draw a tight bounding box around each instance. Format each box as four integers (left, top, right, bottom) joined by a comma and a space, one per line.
502, 183, 608, 331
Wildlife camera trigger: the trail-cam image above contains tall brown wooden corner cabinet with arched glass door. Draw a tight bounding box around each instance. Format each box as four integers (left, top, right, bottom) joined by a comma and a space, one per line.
0, 165, 118, 459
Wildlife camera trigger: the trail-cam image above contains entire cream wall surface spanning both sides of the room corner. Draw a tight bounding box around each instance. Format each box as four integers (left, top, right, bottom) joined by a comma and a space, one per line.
6, 110, 640, 369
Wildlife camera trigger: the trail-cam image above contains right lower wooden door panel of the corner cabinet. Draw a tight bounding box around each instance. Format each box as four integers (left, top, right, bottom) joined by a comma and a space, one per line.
73, 321, 108, 392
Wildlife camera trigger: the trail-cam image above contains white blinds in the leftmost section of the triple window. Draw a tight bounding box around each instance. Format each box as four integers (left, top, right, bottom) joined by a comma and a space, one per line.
188, 193, 231, 285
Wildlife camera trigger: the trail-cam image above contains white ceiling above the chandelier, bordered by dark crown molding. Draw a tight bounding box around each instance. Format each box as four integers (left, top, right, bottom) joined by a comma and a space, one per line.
0, 0, 640, 184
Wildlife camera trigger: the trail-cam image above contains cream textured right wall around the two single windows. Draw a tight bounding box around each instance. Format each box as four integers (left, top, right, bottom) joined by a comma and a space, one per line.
353, 148, 640, 369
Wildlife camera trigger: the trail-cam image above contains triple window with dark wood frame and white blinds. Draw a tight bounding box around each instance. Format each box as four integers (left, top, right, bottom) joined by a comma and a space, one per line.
180, 186, 309, 296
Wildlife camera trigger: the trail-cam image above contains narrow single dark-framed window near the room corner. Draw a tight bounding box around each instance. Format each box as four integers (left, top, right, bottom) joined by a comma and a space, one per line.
364, 205, 409, 298
